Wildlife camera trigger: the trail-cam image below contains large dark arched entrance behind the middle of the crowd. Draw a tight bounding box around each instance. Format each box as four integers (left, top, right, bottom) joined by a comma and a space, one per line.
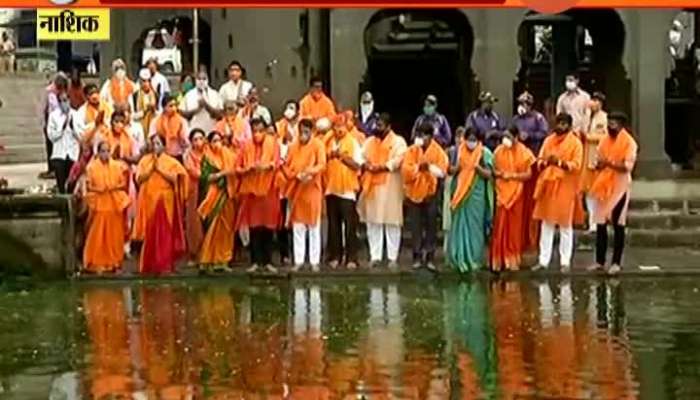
360, 10, 476, 141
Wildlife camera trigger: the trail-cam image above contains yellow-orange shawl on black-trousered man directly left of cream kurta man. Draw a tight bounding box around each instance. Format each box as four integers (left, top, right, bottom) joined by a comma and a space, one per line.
324, 130, 360, 194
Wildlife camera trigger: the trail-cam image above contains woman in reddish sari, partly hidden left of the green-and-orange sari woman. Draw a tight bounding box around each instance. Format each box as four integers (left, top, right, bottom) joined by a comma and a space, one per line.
184, 129, 207, 266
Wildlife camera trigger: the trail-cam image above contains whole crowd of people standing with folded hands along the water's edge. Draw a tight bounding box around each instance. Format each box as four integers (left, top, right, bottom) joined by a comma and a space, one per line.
45, 59, 637, 274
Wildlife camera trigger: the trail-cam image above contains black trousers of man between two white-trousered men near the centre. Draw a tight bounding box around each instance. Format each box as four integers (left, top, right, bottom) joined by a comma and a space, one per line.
326, 195, 358, 262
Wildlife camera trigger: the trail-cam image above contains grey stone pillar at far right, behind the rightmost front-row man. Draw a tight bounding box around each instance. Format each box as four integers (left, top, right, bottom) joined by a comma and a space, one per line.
628, 10, 676, 179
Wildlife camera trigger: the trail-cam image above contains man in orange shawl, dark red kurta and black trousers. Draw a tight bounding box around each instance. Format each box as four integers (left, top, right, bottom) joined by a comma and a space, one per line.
236, 118, 282, 273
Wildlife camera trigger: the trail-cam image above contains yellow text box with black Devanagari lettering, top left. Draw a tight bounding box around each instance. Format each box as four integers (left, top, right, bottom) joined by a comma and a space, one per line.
36, 8, 110, 41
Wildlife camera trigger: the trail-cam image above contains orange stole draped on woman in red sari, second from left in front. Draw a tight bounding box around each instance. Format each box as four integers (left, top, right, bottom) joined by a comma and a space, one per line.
132, 154, 189, 269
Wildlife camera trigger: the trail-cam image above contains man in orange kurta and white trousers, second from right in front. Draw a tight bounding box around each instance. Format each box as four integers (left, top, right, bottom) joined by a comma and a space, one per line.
533, 113, 583, 272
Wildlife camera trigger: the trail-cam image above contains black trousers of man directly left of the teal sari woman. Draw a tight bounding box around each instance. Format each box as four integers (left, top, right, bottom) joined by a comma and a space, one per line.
406, 195, 438, 261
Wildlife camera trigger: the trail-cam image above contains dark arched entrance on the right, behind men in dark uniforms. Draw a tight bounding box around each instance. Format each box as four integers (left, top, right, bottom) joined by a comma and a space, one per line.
513, 9, 631, 122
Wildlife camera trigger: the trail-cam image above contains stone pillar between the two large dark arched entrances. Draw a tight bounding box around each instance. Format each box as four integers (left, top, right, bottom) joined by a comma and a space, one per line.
465, 9, 525, 121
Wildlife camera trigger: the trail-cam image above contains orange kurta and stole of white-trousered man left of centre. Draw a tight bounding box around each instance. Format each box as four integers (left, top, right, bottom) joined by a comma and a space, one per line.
283, 138, 326, 225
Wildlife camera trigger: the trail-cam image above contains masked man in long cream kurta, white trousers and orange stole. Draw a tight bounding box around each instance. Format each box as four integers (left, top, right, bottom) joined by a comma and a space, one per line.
357, 113, 408, 269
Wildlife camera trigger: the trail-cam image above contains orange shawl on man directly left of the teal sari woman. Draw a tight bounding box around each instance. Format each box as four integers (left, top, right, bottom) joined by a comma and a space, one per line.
401, 140, 449, 203
